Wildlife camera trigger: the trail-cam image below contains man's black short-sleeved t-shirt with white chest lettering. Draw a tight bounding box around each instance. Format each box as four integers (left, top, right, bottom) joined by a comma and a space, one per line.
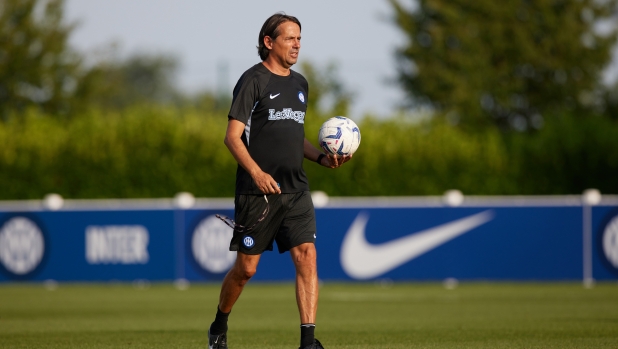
228, 63, 309, 194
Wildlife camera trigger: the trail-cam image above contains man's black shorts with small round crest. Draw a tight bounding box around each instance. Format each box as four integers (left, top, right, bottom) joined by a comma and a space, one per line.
230, 191, 316, 255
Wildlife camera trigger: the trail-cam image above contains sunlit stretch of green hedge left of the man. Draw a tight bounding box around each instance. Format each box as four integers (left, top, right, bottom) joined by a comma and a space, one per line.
0, 107, 236, 199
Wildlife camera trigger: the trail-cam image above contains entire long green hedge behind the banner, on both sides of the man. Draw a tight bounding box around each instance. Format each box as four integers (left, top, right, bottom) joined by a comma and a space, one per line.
0, 106, 618, 200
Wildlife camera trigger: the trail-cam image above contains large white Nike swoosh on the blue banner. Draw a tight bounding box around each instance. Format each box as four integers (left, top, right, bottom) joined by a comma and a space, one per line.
341, 210, 494, 279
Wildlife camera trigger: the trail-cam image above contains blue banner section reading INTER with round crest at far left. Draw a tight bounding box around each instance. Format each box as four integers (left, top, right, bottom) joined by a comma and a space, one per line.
0, 210, 176, 281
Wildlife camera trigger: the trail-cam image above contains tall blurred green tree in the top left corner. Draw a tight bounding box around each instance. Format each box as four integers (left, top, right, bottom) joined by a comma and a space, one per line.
0, 0, 80, 119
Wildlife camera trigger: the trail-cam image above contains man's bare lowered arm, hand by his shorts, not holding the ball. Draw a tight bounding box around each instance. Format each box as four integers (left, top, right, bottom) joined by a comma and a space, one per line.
223, 119, 281, 194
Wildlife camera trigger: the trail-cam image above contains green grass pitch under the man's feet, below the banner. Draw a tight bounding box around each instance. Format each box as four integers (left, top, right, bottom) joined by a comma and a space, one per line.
0, 283, 618, 349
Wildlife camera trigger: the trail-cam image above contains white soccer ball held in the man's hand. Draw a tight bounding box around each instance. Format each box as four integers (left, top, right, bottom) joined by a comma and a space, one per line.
318, 116, 360, 155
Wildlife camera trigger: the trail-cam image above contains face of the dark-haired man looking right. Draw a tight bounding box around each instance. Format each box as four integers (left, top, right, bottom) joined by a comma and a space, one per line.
264, 22, 300, 69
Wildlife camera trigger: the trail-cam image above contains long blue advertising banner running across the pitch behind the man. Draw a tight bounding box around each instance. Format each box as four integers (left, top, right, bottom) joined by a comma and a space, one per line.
0, 198, 618, 282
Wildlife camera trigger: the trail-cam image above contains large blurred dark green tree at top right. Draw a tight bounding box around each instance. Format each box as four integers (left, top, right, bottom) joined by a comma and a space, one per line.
389, 0, 618, 130
